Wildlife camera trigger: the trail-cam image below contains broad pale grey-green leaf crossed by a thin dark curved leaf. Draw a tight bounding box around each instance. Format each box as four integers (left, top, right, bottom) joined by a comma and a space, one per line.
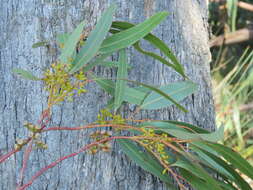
141, 81, 197, 109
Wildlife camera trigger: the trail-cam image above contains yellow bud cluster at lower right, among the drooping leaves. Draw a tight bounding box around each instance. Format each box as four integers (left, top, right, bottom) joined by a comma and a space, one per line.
141, 128, 169, 164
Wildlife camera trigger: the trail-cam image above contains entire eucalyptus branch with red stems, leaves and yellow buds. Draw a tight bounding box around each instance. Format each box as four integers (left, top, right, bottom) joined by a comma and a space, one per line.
0, 6, 253, 190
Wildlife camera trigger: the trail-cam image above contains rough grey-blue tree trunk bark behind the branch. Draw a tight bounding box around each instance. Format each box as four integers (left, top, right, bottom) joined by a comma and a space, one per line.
0, 0, 215, 190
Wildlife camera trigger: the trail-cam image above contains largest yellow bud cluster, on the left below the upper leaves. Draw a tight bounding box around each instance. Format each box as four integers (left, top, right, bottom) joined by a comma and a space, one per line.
42, 63, 87, 106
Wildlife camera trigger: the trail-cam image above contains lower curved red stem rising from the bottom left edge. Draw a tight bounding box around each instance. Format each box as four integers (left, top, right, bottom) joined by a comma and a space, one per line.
17, 136, 132, 190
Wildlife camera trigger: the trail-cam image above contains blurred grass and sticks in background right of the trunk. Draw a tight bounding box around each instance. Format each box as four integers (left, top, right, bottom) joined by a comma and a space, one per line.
209, 0, 253, 174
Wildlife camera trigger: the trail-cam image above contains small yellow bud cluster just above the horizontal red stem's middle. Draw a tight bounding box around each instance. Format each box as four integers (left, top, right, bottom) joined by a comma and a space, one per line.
97, 109, 125, 125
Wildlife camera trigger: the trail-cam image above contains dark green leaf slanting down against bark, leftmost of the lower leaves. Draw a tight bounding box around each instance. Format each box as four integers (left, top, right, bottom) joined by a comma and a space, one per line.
117, 139, 176, 190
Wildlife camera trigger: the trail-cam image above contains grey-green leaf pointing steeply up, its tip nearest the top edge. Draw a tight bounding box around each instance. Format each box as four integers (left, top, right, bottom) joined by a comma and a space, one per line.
70, 5, 116, 73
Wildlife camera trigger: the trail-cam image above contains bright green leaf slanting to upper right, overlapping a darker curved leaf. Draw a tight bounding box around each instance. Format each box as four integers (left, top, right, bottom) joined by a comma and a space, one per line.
99, 12, 168, 53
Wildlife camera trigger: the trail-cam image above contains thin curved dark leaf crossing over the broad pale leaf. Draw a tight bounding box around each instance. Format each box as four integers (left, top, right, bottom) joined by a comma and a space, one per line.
124, 79, 187, 112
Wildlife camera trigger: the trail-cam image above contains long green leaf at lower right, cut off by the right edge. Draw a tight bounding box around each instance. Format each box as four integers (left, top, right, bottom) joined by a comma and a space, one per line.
208, 143, 253, 179
